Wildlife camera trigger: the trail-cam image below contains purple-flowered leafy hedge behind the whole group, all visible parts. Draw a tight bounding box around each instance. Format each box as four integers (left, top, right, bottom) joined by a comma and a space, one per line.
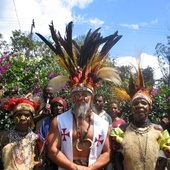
0, 52, 170, 129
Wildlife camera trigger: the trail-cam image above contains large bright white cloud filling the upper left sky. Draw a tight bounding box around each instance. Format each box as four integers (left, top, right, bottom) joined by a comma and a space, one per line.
0, 0, 93, 39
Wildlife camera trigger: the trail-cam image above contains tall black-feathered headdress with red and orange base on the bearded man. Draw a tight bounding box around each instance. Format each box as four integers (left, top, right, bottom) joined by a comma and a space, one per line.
36, 22, 122, 93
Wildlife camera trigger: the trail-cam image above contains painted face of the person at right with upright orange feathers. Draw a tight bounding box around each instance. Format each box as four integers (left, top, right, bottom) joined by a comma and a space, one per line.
132, 98, 150, 121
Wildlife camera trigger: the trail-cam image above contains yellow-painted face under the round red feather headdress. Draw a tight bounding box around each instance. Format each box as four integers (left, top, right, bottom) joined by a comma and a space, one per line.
14, 110, 33, 130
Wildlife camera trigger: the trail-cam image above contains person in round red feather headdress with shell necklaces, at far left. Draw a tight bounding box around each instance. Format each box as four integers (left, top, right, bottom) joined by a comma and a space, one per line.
0, 98, 42, 170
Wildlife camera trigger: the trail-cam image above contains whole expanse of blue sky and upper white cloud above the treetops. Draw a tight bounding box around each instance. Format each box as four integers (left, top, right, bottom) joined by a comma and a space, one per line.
0, 0, 170, 77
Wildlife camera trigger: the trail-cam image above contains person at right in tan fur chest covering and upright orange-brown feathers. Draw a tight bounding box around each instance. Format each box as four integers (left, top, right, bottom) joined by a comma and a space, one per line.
111, 64, 170, 170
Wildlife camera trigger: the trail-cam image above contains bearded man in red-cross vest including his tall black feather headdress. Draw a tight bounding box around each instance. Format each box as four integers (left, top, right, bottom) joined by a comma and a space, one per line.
37, 22, 122, 170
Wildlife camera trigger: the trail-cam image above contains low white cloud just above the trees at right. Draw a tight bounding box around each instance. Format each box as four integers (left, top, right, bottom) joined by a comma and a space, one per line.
116, 53, 165, 79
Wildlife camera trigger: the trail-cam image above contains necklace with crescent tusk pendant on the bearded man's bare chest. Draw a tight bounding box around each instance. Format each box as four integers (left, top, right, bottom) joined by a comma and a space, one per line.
73, 113, 92, 151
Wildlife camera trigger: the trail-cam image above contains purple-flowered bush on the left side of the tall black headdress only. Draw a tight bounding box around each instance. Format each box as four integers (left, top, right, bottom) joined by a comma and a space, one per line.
0, 52, 66, 129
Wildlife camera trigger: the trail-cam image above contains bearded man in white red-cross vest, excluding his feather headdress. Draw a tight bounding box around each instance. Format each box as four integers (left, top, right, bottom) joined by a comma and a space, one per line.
48, 90, 110, 170
